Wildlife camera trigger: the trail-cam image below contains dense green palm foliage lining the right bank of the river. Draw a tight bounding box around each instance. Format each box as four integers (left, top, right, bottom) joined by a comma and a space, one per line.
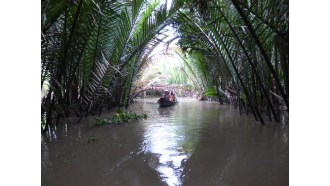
171, 0, 289, 123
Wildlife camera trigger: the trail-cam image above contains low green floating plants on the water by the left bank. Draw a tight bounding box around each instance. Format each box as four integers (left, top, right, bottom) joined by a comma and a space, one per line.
96, 109, 148, 126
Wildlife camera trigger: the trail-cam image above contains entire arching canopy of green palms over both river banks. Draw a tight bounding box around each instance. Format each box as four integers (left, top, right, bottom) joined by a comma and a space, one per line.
41, 0, 289, 130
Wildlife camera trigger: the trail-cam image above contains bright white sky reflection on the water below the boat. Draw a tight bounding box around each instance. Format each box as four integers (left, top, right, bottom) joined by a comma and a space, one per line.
144, 104, 188, 186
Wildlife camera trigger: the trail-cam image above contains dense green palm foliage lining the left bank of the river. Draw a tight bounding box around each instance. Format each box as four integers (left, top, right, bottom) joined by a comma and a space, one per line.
41, 0, 181, 129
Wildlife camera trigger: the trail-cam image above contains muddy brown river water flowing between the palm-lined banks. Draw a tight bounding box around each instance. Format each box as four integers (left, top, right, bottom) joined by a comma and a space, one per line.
41, 99, 289, 186
